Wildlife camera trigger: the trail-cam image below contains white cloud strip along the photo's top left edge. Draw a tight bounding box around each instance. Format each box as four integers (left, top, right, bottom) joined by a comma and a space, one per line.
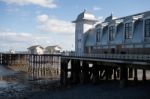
0, 0, 57, 8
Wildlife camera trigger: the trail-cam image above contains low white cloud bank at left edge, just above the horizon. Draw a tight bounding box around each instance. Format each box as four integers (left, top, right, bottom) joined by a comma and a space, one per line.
0, 30, 48, 51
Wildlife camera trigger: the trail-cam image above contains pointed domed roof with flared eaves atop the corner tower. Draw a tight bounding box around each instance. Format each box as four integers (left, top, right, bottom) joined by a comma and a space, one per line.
73, 10, 97, 23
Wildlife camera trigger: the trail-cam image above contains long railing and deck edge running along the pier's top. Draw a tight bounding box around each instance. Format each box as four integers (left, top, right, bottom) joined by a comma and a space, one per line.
0, 53, 150, 64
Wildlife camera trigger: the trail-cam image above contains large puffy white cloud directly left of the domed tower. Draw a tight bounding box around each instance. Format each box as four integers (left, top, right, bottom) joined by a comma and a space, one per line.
37, 14, 74, 34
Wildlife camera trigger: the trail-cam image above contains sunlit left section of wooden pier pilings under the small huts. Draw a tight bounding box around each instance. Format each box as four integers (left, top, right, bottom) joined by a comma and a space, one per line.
0, 53, 60, 80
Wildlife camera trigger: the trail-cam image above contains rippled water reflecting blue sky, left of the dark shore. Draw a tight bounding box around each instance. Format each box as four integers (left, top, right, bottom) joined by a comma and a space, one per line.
0, 65, 59, 99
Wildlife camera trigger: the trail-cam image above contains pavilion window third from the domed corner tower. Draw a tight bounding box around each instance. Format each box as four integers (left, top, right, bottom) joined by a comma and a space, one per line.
125, 22, 132, 39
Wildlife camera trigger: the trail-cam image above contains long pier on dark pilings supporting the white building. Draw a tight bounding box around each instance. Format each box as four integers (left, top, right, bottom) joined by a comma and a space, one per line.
0, 53, 150, 86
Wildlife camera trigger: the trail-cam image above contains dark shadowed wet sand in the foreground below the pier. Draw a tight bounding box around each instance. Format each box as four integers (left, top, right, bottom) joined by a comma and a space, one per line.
27, 82, 150, 99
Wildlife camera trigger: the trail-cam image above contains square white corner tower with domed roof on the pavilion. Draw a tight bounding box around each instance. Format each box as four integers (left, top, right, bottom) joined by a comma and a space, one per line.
73, 10, 97, 54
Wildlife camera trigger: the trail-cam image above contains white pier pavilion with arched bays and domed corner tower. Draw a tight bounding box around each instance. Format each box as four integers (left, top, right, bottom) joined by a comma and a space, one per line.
73, 11, 150, 54
